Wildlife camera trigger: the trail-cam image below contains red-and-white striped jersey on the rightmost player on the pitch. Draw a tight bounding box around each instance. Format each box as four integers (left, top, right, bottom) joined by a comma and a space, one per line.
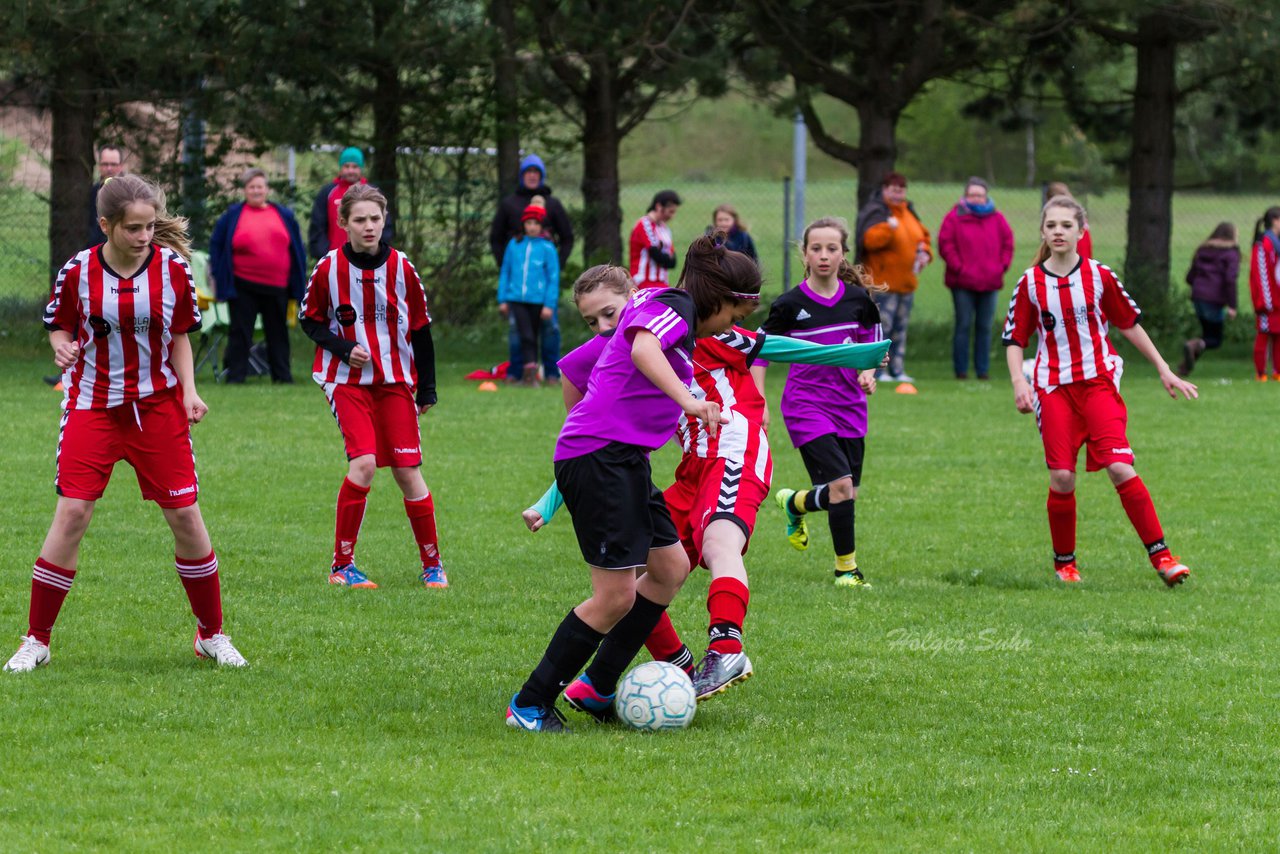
1004, 259, 1140, 391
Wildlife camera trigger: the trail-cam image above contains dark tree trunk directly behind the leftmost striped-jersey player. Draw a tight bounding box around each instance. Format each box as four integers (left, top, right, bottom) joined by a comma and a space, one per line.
42, 63, 97, 286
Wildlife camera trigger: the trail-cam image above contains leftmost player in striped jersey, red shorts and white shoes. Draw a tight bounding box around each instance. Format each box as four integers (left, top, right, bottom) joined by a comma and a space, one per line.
4, 175, 247, 672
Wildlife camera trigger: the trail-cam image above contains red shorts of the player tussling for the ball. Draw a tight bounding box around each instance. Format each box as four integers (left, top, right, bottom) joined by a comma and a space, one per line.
662, 453, 769, 566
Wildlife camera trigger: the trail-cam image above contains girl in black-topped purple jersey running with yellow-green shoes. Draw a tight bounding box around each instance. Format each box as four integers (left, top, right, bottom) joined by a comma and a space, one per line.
751, 218, 882, 588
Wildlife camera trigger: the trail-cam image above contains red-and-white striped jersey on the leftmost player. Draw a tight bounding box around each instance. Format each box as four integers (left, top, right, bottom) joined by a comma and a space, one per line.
45, 245, 200, 410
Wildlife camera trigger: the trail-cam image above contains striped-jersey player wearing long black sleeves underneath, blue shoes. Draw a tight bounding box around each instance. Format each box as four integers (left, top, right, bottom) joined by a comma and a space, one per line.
301, 184, 449, 588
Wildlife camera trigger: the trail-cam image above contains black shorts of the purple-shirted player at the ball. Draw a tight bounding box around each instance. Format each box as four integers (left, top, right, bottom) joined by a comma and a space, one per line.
556, 442, 680, 570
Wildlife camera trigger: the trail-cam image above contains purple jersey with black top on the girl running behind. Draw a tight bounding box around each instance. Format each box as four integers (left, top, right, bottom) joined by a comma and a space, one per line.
760, 282, 883, 447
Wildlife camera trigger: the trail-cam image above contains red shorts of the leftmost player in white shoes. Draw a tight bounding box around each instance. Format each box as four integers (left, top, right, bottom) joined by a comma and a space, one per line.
54, 389, 200, 507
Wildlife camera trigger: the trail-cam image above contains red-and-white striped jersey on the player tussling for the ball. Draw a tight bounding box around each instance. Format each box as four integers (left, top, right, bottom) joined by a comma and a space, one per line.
676, 326, 773, 483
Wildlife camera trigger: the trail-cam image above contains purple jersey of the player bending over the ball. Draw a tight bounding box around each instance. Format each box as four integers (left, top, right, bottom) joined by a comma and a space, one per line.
556, 288, 695, 461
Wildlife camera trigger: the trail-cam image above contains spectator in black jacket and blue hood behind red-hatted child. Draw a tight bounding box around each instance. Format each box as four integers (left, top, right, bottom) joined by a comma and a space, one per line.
489, 154, 573, 382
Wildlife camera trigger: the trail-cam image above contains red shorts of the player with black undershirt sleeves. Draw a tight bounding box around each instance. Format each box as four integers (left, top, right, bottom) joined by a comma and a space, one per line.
324, 383, 422, 469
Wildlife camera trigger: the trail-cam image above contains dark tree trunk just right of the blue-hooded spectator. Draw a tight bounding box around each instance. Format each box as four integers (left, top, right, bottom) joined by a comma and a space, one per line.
582, 72, 623, 266
